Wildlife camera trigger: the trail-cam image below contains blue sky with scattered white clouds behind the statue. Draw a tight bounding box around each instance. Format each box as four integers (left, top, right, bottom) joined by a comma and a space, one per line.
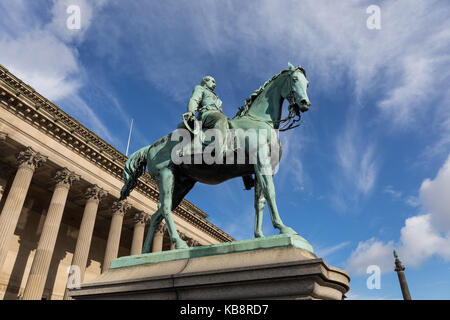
0, 0, 450, 299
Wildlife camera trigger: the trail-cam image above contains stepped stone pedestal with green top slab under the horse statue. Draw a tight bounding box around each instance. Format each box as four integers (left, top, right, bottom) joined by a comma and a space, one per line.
69, 235, 350, 300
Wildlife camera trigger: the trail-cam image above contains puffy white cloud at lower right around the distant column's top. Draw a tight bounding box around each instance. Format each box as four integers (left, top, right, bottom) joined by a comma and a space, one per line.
347, 156, 450, 274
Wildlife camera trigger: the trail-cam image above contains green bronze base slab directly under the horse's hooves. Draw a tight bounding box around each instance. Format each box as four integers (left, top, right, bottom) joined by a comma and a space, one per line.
110, 234, 314, 269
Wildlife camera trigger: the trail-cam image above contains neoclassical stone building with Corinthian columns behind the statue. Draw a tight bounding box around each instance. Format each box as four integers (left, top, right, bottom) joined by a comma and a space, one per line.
0, 65, 234, 300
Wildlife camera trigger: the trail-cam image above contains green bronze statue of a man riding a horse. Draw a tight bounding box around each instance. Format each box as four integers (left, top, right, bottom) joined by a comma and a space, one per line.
120, 64, 311, 253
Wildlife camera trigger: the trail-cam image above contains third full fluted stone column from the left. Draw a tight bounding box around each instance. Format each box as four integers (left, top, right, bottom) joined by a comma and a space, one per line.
64, 185, 108, 300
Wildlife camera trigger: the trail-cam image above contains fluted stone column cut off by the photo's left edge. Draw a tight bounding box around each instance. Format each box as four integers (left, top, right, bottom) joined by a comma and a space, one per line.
0, 147, 47, 270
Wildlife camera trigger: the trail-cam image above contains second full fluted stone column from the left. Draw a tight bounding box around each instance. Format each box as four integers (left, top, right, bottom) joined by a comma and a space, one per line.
23, 168, 80, 300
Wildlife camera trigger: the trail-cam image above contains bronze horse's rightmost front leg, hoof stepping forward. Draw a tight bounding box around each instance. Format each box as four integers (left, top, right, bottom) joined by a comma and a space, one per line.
255, 164, 297, 234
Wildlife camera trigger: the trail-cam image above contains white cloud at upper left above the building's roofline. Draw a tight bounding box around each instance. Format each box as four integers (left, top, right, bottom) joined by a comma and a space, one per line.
0, 0, 116, 142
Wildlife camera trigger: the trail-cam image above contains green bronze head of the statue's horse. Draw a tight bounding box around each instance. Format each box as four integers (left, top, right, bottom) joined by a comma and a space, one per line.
282, 63, 311, 112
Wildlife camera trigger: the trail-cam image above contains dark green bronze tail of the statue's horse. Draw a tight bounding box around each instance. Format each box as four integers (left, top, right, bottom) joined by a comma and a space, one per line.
120, 146, 151, 200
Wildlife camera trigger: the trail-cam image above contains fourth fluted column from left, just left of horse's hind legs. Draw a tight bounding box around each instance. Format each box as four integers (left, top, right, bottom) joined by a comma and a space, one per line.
102, 200, 131, 273
